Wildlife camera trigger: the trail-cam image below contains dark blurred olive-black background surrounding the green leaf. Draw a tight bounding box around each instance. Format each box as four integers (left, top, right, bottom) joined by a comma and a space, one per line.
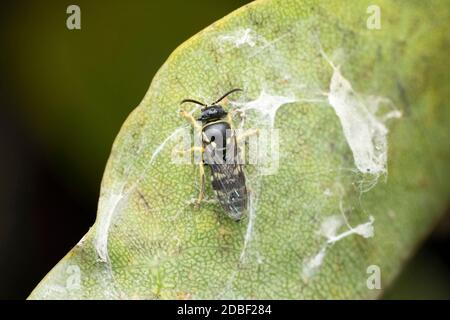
0, 0, 450, 299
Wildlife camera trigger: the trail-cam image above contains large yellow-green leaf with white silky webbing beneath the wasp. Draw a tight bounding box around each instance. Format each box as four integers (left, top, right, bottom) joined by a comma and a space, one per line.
30, 0, 450, 299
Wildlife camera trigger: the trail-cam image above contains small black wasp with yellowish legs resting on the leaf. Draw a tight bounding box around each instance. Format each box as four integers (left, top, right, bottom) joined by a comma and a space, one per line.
179, 88, 258, 220
